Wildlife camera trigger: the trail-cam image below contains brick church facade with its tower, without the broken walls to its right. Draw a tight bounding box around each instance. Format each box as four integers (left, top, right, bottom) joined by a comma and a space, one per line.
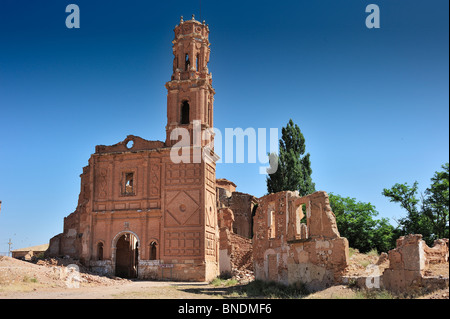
47, 17, 219, 281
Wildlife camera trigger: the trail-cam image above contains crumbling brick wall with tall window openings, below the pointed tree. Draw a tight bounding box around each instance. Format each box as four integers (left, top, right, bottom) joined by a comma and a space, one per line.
253, 191, 348, 290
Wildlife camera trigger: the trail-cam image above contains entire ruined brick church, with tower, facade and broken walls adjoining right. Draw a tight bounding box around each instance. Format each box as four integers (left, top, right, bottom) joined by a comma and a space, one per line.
46, 17, 354, 288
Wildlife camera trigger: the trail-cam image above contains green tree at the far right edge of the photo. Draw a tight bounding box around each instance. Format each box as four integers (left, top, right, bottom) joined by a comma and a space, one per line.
382, 163, 449, 245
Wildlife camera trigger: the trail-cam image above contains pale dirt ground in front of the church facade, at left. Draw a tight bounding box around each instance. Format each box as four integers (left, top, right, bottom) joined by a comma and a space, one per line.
0, 256, 229, 299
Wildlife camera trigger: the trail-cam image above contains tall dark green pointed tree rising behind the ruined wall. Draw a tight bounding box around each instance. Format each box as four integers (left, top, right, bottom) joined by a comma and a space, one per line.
266, 119, 315, 196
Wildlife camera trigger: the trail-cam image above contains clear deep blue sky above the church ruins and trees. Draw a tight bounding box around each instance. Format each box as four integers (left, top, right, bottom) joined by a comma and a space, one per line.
0, 0, 449, 252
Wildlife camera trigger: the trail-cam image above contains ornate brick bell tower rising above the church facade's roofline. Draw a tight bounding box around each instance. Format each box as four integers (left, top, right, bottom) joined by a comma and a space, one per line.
166, 15, 215, 147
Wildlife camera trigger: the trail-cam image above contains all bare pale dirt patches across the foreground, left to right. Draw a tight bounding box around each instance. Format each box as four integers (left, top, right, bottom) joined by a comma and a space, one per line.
0, 253, 449, 299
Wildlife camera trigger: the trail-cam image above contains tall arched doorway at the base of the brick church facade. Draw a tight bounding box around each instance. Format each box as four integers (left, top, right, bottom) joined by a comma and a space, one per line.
113, 232, 139, 278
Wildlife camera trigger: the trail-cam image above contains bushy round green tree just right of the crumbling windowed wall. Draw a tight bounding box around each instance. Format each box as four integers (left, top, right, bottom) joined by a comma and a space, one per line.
329, 193, 396, 253
